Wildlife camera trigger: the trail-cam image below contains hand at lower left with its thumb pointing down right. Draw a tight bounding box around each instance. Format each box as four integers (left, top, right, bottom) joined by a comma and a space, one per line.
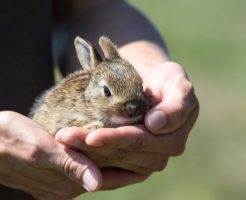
0, 111, 102, 200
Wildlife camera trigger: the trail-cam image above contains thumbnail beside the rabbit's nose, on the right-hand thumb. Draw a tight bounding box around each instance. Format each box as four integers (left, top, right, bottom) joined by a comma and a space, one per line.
147, 110, 166, 131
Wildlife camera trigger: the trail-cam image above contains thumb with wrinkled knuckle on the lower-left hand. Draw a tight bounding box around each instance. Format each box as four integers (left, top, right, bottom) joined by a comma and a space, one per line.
50, 145, 102, 191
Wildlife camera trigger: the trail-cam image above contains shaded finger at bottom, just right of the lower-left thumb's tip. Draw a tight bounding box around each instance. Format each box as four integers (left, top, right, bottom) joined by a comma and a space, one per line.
102, 168, 151, 190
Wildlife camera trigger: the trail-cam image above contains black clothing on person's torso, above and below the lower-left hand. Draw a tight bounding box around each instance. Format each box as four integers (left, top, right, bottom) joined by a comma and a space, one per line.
0, 0, 53, 200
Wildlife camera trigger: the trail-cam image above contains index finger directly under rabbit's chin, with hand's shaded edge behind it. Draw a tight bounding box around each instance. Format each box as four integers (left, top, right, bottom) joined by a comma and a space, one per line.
85, 104, 199, 156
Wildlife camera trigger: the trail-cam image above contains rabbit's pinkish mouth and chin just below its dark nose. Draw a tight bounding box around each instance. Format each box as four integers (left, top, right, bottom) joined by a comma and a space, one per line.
106, 115, 143, 127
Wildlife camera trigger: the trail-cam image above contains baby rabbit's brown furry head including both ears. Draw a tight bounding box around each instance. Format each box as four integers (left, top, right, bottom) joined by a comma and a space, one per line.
74, 36, 146, 127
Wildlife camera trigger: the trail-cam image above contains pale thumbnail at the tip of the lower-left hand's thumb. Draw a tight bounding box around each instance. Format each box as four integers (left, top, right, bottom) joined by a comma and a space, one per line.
82, 169, 99, 192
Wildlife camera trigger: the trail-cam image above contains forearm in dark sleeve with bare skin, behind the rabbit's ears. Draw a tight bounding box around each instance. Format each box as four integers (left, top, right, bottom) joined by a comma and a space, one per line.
59, 1, 168, 73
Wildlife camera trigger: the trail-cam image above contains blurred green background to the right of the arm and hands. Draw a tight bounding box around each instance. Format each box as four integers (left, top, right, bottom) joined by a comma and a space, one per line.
78, 0, 246, 200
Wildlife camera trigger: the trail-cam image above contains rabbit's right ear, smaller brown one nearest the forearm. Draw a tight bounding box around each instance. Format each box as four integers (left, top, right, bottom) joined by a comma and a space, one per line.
99, 36, 120, 60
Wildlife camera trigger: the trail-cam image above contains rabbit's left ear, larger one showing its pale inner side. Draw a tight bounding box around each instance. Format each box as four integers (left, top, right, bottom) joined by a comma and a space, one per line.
74, 36, 102, 70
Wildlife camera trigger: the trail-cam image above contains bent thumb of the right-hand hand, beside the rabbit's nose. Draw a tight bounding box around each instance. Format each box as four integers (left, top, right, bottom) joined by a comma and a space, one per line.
145, 79, 197, 134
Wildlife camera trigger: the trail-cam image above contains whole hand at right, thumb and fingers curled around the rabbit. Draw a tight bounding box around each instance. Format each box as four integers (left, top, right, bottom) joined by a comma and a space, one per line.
56, 62, 199, 186
